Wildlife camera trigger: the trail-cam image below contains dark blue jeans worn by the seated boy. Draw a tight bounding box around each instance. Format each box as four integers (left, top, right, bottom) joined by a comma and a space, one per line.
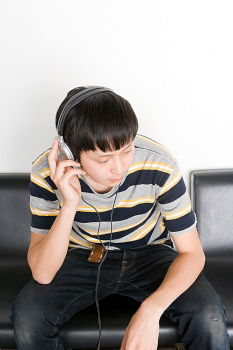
11, 244, 230, 350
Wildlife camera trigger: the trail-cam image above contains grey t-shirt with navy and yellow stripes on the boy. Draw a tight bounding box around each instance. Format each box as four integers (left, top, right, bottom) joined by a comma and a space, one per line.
30, 134, 197, 250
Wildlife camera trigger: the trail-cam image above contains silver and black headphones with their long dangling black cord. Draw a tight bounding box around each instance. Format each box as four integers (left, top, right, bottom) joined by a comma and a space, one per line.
56, 86, 120, 350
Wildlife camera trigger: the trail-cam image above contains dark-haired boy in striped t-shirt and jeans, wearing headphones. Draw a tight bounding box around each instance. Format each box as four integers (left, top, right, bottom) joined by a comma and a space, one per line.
11, 87, 230, 350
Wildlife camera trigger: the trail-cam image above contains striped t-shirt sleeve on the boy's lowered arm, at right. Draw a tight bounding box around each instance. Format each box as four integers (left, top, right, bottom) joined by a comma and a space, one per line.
157, 159, 197, 234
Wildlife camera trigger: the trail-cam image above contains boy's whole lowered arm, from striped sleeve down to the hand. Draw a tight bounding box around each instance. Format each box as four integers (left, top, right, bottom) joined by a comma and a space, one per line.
120, 154, 205, 350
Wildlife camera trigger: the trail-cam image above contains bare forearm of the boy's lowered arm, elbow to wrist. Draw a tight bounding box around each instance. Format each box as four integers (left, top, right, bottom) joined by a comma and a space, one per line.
142, 253, 205, 316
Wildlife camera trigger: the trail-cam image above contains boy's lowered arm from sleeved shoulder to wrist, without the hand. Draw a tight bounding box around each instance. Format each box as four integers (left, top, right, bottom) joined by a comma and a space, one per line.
142, 153, 205, 315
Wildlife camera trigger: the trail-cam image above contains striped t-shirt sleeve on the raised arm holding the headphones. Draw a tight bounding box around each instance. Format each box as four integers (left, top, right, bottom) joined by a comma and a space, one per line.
29, 166, 60, 234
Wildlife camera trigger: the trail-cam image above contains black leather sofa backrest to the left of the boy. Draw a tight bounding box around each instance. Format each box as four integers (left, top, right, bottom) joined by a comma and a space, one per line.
0, 173, 31, 265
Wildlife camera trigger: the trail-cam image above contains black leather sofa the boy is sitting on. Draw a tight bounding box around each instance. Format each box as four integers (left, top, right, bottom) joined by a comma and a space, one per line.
0, 169, 233, 350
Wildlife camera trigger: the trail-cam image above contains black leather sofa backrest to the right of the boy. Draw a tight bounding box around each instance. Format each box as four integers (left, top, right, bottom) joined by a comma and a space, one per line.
190, 169, 233, 259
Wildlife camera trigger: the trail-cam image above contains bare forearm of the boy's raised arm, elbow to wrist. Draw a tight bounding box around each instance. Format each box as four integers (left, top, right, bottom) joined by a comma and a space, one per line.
27, 204, 76, 284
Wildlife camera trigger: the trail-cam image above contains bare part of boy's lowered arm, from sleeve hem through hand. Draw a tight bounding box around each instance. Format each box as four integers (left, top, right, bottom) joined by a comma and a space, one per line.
120, 228, 205, 350
